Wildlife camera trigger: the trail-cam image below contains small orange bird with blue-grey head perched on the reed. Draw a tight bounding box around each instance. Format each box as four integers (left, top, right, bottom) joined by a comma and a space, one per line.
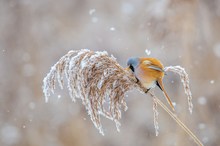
126, 57, 174, 111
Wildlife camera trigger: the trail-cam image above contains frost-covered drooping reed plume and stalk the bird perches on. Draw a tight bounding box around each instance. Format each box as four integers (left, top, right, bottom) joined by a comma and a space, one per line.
43, 49, 202, 145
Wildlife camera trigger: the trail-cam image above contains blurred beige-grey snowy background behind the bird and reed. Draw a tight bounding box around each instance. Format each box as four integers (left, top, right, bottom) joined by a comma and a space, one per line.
0, 0, 220, 146
